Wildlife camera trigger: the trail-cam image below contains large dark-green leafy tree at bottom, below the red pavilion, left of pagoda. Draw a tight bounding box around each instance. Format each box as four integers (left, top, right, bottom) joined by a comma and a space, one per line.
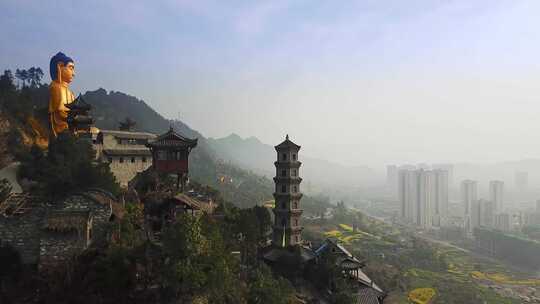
160, 214, 244, 303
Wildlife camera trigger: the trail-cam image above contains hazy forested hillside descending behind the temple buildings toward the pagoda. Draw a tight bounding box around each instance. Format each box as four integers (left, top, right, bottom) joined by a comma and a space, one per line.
83, 89, 326, 212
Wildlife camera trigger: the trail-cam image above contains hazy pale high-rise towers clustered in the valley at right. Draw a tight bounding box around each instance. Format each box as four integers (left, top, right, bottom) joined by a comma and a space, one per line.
387, 163, 540, 236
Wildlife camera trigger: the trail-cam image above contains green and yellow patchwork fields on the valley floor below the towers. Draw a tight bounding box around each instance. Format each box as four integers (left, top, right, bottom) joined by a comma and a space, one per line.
307, 215, 540, 304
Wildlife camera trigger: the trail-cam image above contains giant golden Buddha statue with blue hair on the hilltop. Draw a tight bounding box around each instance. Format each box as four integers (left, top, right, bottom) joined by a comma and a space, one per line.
49, 52, 75, 137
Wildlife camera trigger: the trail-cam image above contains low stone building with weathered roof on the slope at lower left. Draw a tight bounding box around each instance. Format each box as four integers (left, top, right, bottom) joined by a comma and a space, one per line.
0, 189, 123, 271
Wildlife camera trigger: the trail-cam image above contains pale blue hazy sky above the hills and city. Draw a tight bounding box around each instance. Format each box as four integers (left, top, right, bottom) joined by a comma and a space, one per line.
0, 0, 540, 166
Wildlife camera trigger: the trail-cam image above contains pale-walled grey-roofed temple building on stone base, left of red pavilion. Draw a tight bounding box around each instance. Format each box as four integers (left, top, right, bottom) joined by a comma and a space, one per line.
94, 130, 156, 187
